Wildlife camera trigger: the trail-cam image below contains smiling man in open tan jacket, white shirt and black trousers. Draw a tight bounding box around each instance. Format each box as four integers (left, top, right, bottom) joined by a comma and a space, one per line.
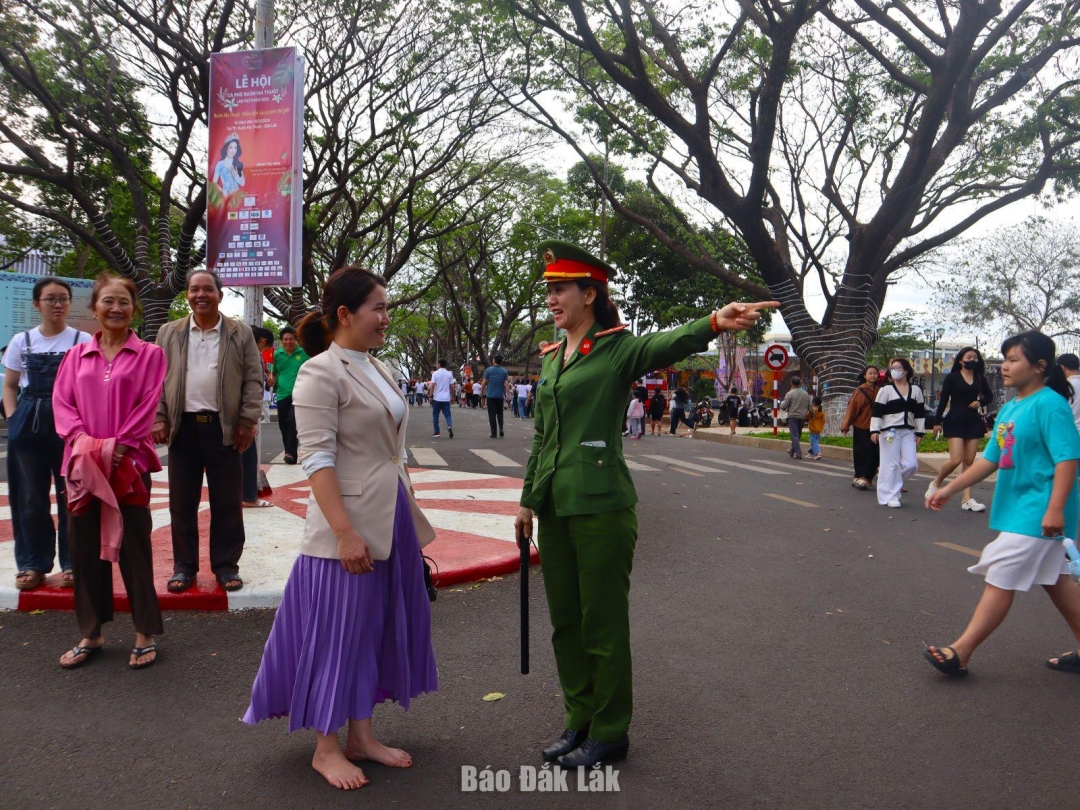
153, 270, 262, 593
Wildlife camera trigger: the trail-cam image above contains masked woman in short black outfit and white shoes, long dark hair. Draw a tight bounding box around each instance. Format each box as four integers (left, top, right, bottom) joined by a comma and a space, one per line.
927, 346, 994, 512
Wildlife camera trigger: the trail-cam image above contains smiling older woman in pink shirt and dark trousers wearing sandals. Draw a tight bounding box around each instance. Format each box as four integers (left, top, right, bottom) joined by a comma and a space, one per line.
53, 275, 165, 669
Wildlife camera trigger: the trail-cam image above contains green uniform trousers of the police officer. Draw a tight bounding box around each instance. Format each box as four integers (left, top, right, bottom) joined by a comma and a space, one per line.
538, 508, 637, 742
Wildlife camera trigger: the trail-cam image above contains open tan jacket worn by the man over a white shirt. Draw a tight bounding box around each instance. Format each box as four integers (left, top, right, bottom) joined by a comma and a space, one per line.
158, 315, 262, 446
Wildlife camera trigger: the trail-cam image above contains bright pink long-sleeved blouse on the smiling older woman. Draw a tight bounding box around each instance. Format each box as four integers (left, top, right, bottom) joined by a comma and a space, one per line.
53, 332, 166, 475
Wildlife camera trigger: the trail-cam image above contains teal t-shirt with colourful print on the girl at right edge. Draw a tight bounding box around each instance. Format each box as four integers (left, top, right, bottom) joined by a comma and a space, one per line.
983, 388, 1080, 537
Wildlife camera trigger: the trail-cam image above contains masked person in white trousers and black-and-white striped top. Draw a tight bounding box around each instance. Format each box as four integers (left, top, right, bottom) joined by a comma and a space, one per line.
870, 357, 927, 509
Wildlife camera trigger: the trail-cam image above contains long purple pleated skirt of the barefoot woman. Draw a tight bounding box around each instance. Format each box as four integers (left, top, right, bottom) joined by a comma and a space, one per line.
244, 484, 438, 734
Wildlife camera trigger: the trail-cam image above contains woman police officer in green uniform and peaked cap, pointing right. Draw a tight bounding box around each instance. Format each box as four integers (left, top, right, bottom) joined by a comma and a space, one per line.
515, 240, 779, 767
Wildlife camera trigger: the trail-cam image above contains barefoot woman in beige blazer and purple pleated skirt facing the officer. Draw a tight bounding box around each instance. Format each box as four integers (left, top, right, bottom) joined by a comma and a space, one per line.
244, 267, 437, 789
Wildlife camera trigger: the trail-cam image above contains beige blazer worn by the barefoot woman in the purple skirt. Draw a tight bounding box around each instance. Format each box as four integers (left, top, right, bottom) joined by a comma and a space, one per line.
293, 343, 435, 559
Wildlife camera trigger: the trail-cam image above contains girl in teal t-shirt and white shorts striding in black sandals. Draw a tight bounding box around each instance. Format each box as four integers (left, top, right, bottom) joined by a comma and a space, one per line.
922, 332, 1080, 677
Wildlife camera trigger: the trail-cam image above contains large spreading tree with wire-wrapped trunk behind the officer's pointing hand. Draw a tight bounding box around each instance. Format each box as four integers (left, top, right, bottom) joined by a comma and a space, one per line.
476, 0, 1080, 409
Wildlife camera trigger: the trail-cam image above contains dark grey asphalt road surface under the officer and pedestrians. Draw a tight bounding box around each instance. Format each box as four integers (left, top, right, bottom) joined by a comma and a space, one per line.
0, 408, 1080, 810
